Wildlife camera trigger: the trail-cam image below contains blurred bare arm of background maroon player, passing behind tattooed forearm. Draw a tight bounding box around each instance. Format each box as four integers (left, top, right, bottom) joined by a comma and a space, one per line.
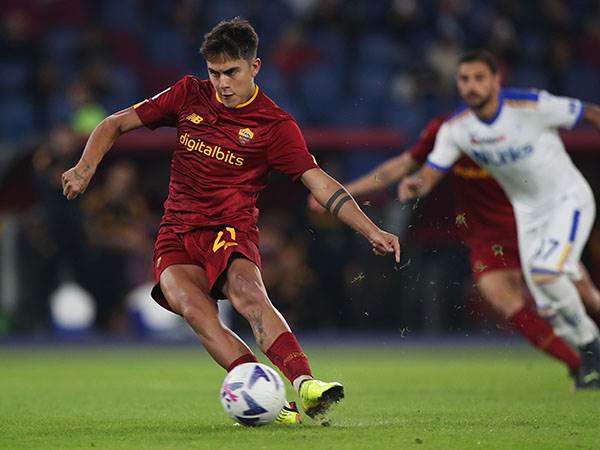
308, 152, 418, 212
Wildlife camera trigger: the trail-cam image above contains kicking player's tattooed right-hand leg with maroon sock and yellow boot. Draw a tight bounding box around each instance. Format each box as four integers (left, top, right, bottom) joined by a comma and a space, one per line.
223, 258, 344, 417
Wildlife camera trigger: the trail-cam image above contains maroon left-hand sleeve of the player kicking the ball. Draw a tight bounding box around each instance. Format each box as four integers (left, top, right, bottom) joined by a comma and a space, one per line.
134, 76, 189, 130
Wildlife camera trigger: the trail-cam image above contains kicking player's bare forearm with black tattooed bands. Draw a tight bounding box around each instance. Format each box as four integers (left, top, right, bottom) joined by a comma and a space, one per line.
302, 169, 400, 262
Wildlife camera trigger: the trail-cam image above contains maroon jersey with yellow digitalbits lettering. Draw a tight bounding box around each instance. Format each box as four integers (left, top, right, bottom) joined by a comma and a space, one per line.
135, 75, 318, 232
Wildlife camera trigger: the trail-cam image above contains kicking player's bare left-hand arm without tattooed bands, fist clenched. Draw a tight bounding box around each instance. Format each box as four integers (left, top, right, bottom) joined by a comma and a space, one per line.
62, 107, 143, 200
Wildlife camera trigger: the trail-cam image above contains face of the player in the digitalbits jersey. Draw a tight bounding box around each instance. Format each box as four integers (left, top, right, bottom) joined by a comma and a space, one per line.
206, 58, 260, 108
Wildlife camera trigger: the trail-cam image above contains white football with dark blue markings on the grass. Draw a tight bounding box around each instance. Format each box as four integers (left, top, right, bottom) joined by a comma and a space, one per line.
221, 363, 285, 426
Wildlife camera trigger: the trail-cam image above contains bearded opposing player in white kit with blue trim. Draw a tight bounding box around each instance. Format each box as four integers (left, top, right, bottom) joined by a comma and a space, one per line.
399, 51, 600, 388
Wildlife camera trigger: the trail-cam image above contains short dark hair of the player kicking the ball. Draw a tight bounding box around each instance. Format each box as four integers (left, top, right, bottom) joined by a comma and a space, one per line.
200, 17, 258, 61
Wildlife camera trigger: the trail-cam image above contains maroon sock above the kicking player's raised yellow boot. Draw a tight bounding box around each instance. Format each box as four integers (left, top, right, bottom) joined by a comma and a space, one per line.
266, 331, 312, 383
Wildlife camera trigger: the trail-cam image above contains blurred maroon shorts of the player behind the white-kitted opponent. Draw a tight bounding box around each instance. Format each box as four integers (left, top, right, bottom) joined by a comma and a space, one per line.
465, 237, 521, 281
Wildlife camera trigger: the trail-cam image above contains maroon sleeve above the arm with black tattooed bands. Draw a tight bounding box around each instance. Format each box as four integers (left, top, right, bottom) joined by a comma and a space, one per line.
267, 120, 319, 181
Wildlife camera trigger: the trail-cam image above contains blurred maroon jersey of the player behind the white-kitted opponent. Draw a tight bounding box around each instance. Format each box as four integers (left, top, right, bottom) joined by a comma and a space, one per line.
409, 115, 517, 242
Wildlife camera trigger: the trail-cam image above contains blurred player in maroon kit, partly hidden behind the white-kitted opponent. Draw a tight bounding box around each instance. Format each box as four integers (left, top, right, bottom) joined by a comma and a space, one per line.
309, 115, 600, 386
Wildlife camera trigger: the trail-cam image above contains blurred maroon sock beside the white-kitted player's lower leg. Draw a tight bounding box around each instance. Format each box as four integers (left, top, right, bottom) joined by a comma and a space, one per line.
508, 306, 581, 368
